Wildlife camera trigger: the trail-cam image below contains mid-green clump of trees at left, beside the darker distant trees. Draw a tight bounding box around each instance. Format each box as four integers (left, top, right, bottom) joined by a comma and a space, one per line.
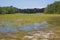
0, 6, 19, 14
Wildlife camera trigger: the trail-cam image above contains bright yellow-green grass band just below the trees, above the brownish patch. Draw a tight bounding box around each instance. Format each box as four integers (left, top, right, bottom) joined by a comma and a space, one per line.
0, 13, 60, 22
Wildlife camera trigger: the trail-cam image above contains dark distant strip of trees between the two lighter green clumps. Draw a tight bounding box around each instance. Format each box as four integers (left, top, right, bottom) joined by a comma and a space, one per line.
19, 8, 44, 13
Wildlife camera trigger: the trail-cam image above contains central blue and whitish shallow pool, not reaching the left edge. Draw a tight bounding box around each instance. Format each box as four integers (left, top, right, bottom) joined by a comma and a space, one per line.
20, 21, 48, 30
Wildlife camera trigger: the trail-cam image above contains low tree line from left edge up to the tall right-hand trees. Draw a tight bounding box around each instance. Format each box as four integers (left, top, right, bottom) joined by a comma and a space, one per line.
0, 6, 44, 14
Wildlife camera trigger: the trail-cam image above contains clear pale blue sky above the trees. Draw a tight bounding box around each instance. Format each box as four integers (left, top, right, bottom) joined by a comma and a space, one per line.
0, 0, 58, 8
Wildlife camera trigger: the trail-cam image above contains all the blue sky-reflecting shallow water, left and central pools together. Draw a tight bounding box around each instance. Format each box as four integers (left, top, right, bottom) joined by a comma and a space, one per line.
0, 21, 48, 32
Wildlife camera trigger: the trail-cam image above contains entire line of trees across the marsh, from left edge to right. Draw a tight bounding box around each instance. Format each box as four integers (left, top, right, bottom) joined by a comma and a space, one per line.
0, 1, 60, 14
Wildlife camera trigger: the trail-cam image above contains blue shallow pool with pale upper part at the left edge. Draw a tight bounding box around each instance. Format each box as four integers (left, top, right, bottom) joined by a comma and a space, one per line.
0, 22, 18, 32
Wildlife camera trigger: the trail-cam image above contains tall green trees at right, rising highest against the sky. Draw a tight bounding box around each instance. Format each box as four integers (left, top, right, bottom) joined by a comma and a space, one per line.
45, 1, 60, 14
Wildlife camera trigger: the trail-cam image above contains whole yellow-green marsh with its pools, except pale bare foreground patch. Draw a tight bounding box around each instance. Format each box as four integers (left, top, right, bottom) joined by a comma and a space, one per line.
0, 13, 60, 40
